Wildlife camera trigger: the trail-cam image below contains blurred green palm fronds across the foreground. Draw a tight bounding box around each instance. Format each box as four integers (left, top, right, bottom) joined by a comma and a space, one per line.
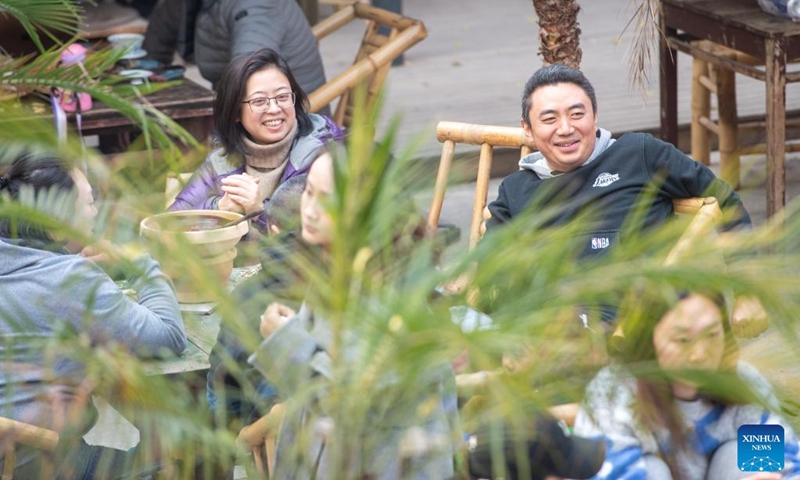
0, 2, 800, 478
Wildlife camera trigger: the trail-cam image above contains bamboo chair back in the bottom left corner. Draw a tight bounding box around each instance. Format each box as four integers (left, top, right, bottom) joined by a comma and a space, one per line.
0, 417, 59, 480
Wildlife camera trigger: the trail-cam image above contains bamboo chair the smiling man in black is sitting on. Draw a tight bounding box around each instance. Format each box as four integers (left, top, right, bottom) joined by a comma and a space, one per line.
427, 121, 721, 425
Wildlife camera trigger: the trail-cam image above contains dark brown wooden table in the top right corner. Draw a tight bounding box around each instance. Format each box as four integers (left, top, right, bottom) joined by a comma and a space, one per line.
659, 0, 800, 217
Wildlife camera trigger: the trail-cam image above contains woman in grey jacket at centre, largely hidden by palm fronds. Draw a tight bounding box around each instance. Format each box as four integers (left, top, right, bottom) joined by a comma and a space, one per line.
249, 150, 458, 480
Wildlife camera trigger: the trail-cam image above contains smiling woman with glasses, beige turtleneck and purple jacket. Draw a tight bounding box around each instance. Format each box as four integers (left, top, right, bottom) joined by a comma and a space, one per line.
169, 48, 343, 231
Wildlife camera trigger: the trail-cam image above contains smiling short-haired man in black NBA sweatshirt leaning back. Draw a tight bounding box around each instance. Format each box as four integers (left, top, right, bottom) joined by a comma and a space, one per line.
487, 64, 768, 336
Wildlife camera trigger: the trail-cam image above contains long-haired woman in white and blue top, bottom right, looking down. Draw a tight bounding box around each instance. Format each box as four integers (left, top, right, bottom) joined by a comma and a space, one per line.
574, 293, 800, 480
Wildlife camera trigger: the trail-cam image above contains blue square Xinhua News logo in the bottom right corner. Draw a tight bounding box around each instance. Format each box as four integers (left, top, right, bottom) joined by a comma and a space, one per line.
737, 425, 784, 472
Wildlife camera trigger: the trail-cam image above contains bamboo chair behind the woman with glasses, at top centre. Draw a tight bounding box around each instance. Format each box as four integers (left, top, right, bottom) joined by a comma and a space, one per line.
308, 2, 428, 128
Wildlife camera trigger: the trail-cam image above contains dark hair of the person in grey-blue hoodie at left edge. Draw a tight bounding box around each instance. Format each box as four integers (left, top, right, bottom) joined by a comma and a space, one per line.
0, 154, 75, 242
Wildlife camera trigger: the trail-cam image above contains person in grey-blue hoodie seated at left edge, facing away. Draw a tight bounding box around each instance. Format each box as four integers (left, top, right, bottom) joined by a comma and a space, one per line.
0, 155, 186, 479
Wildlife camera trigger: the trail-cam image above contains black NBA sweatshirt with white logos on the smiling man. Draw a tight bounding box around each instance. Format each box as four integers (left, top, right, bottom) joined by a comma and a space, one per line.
487, 133, 750, 254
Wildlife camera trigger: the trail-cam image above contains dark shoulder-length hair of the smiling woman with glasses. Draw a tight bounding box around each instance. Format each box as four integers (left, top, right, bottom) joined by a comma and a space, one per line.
214, 48, 313, 155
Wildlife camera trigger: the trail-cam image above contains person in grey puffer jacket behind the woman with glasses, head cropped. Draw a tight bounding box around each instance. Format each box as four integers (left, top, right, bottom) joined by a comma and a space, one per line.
142, 0, 325, 97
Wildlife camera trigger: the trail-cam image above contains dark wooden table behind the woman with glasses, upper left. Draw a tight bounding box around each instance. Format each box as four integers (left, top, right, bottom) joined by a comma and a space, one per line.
78, 79, 214, 148
